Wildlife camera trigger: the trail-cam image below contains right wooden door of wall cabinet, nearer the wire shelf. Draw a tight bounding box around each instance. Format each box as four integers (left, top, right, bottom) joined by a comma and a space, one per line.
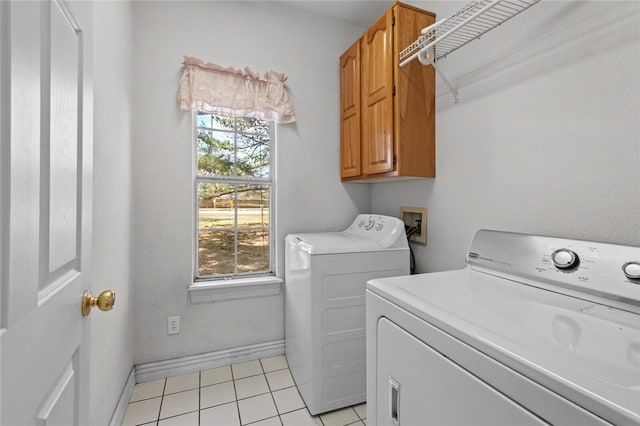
361, 12, 394, 174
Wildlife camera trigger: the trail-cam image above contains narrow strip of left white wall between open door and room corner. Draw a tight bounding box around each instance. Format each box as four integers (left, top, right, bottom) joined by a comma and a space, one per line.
90, 1, 134, 425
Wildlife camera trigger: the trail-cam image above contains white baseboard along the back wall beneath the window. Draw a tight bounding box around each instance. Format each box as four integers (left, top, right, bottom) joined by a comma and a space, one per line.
134, 339, 284, 384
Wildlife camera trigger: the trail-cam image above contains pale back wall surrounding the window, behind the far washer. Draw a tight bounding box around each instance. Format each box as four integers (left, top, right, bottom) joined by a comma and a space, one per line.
133, 1, 370, 363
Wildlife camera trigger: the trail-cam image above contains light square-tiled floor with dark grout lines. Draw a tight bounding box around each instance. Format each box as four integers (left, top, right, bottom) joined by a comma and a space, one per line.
123, 355, 367, 426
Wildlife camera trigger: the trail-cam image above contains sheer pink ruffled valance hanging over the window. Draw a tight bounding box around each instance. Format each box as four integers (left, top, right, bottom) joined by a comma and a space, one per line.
178, 56, 296, 123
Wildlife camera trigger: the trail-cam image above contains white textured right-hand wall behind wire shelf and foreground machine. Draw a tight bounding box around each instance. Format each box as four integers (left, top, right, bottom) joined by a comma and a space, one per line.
371, 1, 640, 272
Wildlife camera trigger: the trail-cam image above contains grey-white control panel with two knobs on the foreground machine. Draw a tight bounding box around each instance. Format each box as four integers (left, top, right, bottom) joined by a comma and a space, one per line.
466, 230, 640, 309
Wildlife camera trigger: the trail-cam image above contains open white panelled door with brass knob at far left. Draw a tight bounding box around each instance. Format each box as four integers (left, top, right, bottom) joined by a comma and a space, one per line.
0, 0, 93, 426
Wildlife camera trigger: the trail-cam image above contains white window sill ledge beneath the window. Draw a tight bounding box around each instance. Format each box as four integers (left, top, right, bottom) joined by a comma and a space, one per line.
189, 276, 282, 304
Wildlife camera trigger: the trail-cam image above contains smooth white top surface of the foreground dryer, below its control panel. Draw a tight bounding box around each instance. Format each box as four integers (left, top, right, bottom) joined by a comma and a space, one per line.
367, 268, 640, 424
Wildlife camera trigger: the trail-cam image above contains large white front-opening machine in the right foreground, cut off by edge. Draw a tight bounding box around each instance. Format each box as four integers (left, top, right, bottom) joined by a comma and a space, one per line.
366, 231, 640, 426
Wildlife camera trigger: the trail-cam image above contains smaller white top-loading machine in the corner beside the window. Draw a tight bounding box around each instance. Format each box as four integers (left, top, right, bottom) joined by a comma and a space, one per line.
285, 215, 409, 414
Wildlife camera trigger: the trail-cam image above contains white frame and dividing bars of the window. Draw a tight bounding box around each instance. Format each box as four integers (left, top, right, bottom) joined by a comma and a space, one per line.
190, 111, 279, 282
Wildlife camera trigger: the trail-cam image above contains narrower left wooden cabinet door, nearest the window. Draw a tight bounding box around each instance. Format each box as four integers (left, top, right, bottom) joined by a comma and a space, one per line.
340, 40, 361, 178
